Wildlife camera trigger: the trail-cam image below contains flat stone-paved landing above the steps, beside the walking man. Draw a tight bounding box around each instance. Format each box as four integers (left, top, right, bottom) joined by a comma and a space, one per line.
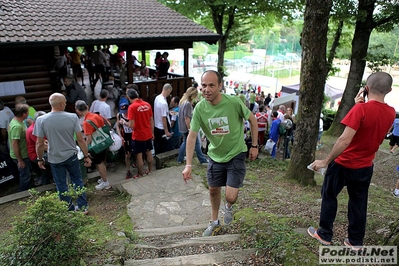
122, 166, 219, 229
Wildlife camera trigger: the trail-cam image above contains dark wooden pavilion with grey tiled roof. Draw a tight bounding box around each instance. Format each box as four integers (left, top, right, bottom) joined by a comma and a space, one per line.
0, 0, 219, 110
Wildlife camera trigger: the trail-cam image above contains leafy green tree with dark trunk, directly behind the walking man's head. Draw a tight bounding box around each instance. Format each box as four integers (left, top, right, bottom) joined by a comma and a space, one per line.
160, 0, 301, 75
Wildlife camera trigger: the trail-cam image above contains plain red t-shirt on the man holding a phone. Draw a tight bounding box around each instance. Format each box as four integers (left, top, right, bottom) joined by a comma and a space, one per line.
335, 100, 396, 169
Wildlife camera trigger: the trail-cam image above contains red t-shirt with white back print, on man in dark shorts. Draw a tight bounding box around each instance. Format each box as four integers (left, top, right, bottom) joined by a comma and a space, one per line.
127, 99, 153, 141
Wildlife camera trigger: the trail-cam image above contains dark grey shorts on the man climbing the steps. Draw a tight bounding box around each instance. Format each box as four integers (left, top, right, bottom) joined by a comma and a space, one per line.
207, 152, 246, 188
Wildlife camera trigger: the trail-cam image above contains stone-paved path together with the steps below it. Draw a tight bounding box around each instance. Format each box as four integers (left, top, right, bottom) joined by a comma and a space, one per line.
121, 166, 258, 266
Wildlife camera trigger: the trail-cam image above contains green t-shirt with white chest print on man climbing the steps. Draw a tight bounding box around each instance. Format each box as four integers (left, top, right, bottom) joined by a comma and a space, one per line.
190, 94, 251, 163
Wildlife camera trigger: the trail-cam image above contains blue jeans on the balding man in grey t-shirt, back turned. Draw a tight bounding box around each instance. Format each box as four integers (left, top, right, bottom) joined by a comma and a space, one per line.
50, 154, 87, 210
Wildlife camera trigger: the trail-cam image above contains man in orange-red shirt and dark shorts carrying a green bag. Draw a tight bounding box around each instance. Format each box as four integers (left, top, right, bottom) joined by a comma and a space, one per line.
75, 100, 111, 190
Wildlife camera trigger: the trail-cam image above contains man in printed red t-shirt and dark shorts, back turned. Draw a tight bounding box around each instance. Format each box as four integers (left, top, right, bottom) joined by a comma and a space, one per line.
125, 89, 154, 178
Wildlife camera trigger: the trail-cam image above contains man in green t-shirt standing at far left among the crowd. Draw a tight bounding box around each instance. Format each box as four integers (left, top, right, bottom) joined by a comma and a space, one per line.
8, 103, 30, 191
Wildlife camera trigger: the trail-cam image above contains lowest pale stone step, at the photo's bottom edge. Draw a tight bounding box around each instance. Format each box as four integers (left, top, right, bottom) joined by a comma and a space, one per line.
124, 248, 257, 266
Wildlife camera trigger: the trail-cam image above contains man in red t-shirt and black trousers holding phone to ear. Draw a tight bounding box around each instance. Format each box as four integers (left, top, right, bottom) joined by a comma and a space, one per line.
308, 72, 396, 250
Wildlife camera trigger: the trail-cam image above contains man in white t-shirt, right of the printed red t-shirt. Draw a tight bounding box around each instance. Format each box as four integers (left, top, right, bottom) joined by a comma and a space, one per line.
154, 83, 173, 154
